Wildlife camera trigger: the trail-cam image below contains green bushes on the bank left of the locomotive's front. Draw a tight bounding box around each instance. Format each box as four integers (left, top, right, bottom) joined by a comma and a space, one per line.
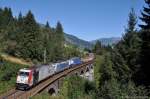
0, 61, 28, 94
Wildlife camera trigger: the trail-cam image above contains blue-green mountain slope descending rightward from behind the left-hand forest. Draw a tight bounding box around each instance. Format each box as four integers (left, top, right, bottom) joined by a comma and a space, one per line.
64, 33, 93, 49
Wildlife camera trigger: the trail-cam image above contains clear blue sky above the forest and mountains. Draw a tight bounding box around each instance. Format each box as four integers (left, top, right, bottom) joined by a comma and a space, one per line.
0, 0, 144, 41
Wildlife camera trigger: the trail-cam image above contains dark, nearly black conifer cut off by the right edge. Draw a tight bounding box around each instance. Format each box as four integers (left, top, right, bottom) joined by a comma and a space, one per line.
139, 0, 150, 85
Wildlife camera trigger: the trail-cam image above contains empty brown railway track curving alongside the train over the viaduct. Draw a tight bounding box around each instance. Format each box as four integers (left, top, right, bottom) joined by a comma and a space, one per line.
0, 60, 93, 99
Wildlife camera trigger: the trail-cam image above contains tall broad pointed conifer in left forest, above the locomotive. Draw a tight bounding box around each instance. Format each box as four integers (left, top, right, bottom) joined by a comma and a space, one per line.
20, 11, 43, 60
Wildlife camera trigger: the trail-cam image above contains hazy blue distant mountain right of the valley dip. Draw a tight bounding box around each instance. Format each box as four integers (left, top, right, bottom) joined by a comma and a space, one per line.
91, 37, 121, 45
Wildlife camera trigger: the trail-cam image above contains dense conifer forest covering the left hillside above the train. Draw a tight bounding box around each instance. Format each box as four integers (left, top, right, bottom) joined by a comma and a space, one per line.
0, 7, 81, 63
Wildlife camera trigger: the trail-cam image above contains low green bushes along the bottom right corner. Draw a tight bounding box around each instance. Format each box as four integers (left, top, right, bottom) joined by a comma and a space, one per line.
97, 79, 148, 99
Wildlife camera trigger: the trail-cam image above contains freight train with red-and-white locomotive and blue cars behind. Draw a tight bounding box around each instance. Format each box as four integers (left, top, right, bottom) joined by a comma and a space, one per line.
16, 57, 82, 90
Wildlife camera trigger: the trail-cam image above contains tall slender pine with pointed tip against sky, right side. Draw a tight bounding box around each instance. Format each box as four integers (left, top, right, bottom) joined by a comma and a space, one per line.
122, 8, 141, 72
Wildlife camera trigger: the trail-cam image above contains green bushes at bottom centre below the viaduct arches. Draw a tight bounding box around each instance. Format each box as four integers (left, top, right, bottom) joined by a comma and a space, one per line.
60, 76, 95, 99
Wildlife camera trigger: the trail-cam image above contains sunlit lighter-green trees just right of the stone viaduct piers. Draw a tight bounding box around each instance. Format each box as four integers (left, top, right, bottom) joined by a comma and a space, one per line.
94, 53, 116, 89
